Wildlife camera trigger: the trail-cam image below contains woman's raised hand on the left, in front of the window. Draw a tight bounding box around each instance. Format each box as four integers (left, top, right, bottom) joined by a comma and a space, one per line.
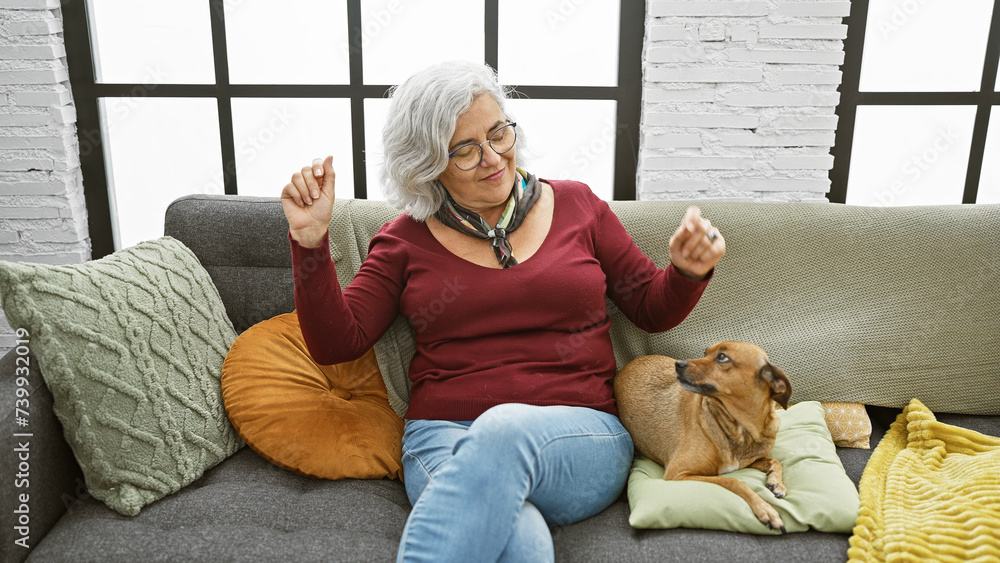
281, 156, 336, 247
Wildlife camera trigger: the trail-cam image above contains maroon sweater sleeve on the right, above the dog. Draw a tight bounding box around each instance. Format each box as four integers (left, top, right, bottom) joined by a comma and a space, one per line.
594, 196, 715, 332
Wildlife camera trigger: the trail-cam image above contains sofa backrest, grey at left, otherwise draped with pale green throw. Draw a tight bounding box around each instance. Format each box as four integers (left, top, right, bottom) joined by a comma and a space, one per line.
167, 196, 1000, 414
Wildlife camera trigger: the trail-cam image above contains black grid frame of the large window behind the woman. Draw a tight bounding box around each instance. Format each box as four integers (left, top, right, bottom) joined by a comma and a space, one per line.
62, 0, 646, 259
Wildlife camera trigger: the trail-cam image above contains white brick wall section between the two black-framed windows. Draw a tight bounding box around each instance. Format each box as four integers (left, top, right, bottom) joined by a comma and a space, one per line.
637, 0, 850, 201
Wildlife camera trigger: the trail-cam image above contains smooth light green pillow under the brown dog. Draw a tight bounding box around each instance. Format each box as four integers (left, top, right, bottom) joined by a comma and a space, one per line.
628, 401, 859, 534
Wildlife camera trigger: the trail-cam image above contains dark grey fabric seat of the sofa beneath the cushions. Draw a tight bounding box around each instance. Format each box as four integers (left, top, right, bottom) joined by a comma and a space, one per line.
31, 448, 869, 563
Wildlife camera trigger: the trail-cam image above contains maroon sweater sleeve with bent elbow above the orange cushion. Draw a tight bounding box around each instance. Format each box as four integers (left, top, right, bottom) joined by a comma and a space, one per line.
288, 229, 402, 365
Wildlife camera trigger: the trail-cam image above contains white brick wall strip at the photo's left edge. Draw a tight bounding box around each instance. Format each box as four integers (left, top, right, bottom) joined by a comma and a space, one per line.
0, 0, 90, 354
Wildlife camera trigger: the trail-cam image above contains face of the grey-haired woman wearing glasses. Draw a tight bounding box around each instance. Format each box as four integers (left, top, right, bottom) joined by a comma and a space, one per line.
438, 94, 517, 214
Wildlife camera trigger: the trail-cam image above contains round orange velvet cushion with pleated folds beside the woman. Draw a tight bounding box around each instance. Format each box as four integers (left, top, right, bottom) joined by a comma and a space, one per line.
222, 312, 403, 479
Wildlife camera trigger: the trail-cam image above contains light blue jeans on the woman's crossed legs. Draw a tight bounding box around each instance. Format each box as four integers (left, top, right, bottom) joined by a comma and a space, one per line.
397, 404, 632, 562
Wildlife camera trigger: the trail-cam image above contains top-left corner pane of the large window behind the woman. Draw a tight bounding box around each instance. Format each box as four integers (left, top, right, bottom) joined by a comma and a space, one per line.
88, 0, 215, 84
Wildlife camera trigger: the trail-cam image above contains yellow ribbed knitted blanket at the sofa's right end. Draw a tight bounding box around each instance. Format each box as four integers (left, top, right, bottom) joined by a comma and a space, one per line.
847, 399, 1000, 561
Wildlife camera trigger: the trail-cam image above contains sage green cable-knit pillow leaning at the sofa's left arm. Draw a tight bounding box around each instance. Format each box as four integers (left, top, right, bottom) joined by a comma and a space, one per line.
0, 237, 243, 516
